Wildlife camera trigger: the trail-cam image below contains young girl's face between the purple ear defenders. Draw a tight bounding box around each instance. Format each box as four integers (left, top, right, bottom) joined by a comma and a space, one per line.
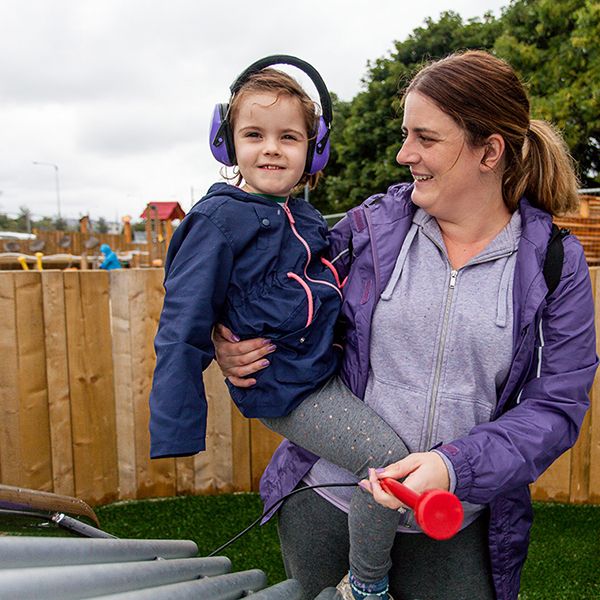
233, 92, 308, 196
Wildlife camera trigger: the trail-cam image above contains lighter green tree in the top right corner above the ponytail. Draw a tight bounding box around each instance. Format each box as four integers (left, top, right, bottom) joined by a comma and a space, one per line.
495, 0, 600, 185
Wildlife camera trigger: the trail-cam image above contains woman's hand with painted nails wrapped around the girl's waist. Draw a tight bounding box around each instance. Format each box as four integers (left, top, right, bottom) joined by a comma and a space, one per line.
213, 324, 276, 388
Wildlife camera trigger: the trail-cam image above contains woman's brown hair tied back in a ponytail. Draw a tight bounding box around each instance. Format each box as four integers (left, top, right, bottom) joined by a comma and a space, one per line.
404, 50, 579, 215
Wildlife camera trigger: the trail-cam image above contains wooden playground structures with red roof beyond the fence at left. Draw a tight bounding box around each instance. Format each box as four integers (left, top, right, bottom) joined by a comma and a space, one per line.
0, 202, 185, 270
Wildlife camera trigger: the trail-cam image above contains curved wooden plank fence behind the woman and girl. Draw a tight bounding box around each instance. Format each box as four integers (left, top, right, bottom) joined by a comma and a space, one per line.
0, 269, 600, 505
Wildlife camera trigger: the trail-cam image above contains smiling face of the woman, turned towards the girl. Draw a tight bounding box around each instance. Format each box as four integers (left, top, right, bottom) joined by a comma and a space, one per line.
396, 92, 484, 220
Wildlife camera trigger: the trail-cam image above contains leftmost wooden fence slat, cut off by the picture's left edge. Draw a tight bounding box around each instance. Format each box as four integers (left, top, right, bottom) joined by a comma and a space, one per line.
0, 272, 21, 485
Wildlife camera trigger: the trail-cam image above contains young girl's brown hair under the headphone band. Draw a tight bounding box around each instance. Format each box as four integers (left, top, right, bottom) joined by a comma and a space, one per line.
229, 68, 321, 193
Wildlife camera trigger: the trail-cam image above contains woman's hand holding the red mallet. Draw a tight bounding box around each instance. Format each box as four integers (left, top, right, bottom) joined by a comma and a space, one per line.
360, 452, 450, 510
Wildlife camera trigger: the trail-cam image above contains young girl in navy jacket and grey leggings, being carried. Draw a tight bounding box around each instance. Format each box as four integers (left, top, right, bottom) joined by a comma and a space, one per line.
150, 57, 408, 598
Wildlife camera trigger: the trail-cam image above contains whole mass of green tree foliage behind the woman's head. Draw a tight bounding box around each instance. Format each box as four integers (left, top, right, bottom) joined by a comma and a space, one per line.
311, 0, 600, 213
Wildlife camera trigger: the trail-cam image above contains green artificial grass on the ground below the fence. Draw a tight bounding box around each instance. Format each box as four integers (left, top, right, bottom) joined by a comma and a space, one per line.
96, 494, 600, 600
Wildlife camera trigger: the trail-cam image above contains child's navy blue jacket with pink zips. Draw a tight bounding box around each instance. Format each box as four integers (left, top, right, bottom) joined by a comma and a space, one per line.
150, 183, 341, 458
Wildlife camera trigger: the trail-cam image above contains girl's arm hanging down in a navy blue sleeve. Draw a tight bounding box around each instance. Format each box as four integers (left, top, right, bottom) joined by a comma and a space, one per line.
150, 213, 233, 458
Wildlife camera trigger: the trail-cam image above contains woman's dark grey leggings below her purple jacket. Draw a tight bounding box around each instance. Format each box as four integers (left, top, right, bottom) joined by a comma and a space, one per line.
278, 482, 496, 600
